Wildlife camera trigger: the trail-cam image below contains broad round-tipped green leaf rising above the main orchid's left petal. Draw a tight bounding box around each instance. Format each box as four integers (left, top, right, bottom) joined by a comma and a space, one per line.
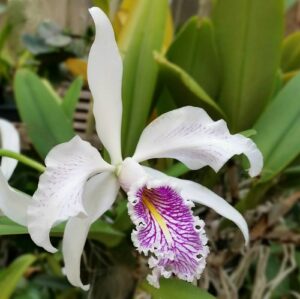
14, 70, 74, 157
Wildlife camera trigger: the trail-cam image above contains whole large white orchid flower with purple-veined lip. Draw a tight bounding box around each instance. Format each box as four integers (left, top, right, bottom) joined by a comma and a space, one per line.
28, 8, 263, 290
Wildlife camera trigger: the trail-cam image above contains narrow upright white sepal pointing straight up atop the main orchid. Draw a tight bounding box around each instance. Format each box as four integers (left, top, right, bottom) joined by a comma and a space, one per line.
88, 7, 123, 164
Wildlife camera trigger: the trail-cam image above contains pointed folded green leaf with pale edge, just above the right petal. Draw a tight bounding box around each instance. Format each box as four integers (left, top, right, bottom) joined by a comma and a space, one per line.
155, 54, 226, 118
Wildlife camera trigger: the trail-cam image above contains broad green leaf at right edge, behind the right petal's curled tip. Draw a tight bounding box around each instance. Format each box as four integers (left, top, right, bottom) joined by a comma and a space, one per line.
253, 75, 300, 181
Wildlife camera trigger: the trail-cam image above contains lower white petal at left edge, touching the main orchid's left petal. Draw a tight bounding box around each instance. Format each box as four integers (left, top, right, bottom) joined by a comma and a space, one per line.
0, 170, 32, 226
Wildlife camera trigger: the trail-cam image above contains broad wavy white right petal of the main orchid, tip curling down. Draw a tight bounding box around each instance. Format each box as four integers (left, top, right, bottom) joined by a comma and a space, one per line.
133, 106, 263, 176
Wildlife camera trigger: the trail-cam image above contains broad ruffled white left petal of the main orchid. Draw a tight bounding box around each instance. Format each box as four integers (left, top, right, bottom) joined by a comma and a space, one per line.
28, 136, 114, 252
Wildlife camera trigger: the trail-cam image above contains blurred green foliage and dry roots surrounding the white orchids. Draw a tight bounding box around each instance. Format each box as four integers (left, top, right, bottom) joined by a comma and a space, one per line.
0, 0, 300, 299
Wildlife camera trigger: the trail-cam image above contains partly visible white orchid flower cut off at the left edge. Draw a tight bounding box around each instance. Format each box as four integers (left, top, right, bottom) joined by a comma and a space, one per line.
0, 119, 30, 225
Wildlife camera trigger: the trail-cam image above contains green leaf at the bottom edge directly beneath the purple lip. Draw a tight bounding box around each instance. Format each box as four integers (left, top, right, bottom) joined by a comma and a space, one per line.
142, 279, 215, 299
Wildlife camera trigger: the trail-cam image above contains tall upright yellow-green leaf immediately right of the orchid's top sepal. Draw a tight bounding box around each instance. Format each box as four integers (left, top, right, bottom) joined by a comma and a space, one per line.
118, 0, 168, 156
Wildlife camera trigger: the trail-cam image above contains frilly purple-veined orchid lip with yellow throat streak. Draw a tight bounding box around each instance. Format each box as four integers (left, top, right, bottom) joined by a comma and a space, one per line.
128, 183, 209, 287
